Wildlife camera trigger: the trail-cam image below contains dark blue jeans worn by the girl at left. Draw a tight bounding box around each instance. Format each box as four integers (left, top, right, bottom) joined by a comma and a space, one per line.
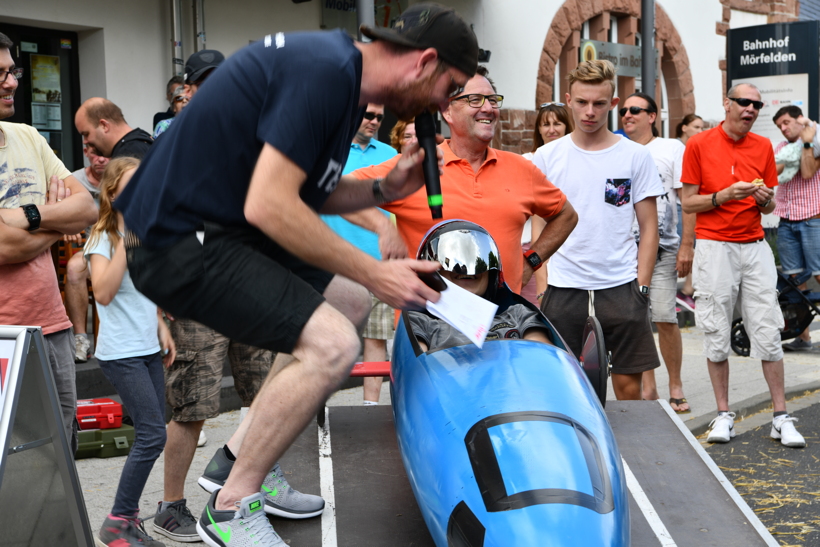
99, 352, 165, 516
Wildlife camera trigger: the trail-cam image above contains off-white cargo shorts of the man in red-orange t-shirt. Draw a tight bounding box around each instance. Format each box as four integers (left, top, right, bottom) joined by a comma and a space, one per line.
692, 239, 783, 363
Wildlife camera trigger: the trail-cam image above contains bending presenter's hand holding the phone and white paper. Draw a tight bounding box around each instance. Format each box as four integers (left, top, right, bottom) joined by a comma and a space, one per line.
367, 258, 441, 310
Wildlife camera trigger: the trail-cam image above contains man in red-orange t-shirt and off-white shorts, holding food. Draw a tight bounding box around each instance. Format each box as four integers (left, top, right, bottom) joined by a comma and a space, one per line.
681, 84, 806, 447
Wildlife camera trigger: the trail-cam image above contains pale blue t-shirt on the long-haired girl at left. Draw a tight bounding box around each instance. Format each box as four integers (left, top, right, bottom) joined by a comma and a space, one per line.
85, 232, 160, 361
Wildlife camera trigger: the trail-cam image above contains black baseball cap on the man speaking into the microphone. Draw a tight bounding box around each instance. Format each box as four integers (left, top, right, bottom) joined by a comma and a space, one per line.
361, 3, 478, 77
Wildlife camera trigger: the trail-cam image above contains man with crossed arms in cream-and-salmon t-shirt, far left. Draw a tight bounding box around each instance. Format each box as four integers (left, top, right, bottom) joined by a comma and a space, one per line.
0, 33, 97, 453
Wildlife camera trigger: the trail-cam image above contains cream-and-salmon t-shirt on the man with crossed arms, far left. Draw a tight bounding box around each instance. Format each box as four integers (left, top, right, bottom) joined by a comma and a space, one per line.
0, 122, 71, 334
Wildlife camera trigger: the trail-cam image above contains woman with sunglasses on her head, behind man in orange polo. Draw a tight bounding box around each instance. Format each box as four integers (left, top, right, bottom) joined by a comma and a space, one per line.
521, 103, 573, 306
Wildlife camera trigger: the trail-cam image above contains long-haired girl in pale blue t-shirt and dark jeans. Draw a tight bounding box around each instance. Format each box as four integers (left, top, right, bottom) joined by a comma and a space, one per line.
85, 158, 176, 547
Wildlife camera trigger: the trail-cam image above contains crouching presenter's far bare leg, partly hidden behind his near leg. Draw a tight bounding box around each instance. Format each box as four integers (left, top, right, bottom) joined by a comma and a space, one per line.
227, 275, 371, 456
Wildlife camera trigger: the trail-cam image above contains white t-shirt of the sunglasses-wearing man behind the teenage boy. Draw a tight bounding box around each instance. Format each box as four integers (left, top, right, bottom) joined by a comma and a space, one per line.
632, 138, 686, 253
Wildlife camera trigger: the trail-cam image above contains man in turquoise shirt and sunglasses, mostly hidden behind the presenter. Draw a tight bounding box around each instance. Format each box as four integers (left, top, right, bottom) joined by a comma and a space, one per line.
322, 104, 398, 405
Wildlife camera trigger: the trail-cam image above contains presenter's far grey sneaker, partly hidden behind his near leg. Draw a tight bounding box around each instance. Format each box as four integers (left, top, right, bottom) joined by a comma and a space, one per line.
197, 448, 325, 519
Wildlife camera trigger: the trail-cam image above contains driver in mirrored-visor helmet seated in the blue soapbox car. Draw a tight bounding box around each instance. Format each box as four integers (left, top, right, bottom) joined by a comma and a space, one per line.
408, 220, 552, 352
